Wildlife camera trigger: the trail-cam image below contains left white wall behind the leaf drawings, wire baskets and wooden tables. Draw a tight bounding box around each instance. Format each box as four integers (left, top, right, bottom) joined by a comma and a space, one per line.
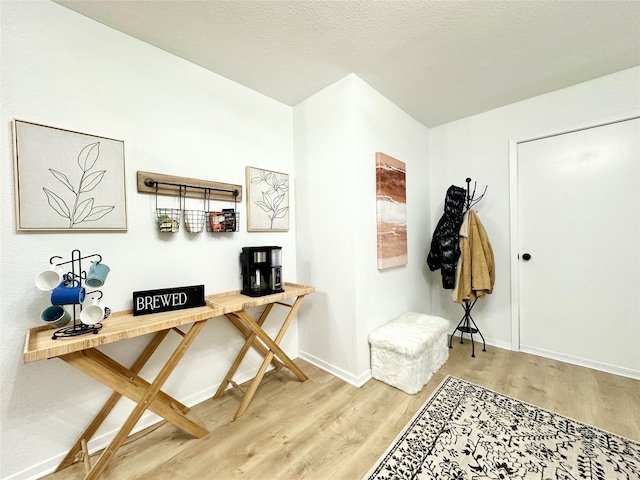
0, 1, 304, 479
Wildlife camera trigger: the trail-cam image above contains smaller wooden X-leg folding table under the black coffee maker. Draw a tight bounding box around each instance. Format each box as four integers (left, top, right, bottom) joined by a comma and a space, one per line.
206, 283, 314, 419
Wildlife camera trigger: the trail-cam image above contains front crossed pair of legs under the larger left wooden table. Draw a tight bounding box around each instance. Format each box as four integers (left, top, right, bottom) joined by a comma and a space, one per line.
61, 320, 208, 480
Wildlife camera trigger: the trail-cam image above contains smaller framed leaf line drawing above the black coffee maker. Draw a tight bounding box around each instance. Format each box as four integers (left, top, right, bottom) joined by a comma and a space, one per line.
246, 167, 289, 232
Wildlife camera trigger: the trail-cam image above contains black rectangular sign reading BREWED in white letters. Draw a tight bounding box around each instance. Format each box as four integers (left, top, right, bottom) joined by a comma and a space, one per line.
133, 285, 206, 316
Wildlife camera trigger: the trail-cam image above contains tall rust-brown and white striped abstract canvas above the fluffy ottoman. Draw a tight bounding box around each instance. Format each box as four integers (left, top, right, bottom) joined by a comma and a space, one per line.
376, 152, 407, 270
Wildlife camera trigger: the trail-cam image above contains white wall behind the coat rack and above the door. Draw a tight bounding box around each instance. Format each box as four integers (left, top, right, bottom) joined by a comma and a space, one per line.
429, 67, 640, 348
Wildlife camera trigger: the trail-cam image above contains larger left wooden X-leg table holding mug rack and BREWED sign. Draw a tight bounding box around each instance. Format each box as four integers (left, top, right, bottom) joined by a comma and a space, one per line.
24, 306, 222, 480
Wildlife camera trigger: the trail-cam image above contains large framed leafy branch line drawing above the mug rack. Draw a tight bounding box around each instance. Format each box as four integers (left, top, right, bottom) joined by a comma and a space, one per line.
13, 120, 127, 232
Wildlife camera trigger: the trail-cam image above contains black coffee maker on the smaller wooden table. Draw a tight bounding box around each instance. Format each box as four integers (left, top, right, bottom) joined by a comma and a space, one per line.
240, 247, 284, 297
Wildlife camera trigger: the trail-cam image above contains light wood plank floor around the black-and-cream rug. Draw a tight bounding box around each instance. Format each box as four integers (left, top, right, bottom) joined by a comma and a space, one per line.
43, 341, 640, 480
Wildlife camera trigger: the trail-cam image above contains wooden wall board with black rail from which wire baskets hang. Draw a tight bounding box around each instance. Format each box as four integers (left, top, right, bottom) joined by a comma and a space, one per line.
137, 171, 242, 202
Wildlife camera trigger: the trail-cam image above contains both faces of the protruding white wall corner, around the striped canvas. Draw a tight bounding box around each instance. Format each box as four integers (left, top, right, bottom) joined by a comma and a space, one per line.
294, 75, 431, 384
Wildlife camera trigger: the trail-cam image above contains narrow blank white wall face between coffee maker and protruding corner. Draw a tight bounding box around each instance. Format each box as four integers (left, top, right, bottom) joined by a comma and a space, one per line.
294, 77, 358, 383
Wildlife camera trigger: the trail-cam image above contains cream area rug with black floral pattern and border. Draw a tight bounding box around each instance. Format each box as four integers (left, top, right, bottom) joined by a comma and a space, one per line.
365, 376, 640, 480
